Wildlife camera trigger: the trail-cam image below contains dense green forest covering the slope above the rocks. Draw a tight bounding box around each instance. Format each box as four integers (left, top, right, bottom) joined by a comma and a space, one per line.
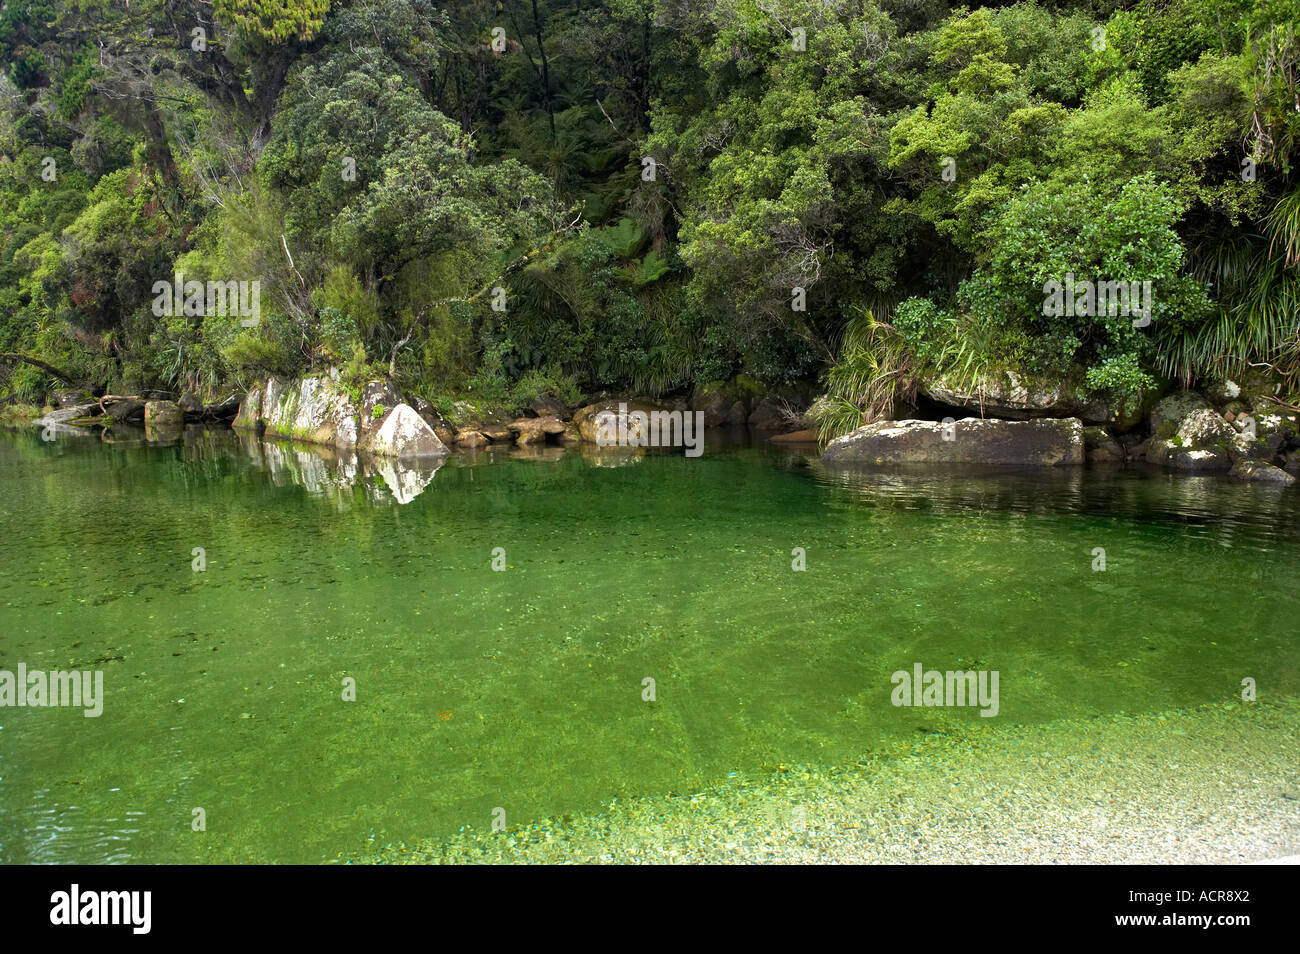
0, 0, 1300, 430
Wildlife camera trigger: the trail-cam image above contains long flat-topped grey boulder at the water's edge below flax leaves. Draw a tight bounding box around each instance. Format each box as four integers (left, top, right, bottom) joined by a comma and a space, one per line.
822, 417, 1083, 467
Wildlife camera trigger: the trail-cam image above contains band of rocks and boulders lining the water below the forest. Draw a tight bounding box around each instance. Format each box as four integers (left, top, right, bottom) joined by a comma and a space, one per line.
17, 369, 1300, 486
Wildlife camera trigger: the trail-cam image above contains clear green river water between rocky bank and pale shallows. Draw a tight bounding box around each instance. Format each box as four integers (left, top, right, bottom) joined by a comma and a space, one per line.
0, 433, 1300, 863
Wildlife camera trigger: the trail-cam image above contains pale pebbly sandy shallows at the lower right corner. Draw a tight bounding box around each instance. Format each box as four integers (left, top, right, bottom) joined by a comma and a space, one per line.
369, 699, 1300, 864
